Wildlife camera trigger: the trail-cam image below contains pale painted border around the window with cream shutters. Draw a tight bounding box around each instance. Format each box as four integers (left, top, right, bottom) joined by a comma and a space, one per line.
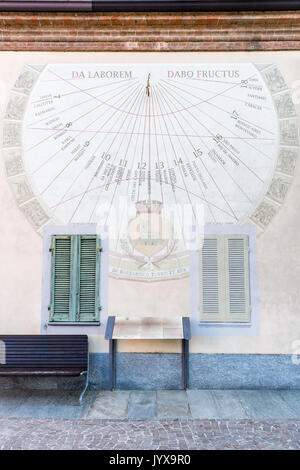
190, 224, 259, 336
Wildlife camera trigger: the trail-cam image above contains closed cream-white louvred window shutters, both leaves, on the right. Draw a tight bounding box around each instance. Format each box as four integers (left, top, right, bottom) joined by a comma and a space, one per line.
199, 235, 251, 323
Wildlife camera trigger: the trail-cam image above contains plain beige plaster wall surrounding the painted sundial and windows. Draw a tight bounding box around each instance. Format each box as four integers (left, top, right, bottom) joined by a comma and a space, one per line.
0, 51, 300, 354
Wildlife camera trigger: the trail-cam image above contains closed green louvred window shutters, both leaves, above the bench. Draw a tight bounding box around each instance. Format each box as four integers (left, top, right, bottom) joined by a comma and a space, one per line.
49, 235, 101, 322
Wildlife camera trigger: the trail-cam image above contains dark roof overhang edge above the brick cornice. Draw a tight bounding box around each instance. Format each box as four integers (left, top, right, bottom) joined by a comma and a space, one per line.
0, 0, 300, 12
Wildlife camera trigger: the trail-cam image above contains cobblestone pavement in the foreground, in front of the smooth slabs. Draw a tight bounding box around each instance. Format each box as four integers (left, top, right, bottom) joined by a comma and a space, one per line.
0, 418, 300, 450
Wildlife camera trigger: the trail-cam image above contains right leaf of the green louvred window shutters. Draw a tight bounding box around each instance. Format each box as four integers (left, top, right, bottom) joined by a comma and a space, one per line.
77, 235, 101, 322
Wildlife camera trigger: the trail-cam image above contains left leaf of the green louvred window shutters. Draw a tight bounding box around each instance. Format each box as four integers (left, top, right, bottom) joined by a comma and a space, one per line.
50, 235, 71, 321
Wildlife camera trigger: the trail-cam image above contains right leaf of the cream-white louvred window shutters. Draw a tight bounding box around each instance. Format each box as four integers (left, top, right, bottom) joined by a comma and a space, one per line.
225, 235, 251, 323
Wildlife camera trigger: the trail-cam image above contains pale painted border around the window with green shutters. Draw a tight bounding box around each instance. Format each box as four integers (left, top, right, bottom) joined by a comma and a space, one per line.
41, 224, 108, 334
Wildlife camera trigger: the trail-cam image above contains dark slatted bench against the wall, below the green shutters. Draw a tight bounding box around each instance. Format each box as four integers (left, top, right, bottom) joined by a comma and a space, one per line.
0, 335, 89, 404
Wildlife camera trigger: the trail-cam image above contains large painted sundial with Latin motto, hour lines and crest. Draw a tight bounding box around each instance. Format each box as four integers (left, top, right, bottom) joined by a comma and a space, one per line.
3, 63, 299, 280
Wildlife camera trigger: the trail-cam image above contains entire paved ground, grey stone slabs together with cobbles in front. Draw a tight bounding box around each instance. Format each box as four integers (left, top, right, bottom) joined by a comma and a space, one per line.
0, 390, 300, 450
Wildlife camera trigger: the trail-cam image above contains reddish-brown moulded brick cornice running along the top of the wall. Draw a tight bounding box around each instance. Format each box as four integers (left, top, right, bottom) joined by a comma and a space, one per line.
0, 10, 300, 52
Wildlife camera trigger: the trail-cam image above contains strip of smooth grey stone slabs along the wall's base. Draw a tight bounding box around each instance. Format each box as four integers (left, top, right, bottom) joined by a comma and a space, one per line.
0, 390, 300, 420
